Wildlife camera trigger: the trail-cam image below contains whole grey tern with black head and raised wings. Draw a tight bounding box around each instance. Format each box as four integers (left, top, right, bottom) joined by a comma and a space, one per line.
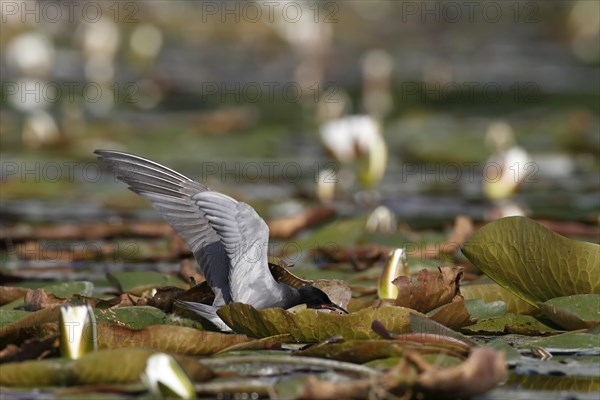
94, 150, 347, 331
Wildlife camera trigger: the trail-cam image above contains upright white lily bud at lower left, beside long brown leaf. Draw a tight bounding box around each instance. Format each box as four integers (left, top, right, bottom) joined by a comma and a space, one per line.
60, 304, 98, 360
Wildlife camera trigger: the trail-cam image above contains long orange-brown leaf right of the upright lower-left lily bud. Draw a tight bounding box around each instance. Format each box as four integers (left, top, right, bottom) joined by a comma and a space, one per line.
98, 324, 254, 355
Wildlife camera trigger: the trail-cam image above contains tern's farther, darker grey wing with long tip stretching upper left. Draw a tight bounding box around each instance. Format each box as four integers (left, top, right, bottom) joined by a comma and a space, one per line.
94, 150, 231, 306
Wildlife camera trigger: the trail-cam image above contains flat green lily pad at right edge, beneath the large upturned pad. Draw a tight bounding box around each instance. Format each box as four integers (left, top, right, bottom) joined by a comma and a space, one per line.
539, 294, 600, 330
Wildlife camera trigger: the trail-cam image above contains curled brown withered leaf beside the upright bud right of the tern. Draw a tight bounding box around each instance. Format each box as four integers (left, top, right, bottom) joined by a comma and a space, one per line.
393, 267, 463, 312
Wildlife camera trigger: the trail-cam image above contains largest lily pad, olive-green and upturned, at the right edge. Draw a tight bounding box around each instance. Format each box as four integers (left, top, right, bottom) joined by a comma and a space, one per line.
462, 217, 600, 305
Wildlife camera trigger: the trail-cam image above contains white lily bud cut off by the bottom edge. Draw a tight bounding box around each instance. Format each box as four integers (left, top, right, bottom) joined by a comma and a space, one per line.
141, 353, 196, 399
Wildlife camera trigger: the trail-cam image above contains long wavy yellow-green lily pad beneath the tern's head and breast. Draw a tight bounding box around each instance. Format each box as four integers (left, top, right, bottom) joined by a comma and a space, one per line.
218, 303, 414, 342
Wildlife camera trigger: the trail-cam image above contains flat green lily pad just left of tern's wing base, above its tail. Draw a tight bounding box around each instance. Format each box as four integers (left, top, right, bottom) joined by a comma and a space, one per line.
106, 272, 189, 296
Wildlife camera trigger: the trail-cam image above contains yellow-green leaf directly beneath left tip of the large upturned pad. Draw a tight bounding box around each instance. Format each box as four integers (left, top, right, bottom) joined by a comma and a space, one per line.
460, 283, 538, 315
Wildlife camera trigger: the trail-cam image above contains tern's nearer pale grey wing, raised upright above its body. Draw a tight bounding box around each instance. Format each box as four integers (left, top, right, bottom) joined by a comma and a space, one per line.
192, 191, 288, 308
